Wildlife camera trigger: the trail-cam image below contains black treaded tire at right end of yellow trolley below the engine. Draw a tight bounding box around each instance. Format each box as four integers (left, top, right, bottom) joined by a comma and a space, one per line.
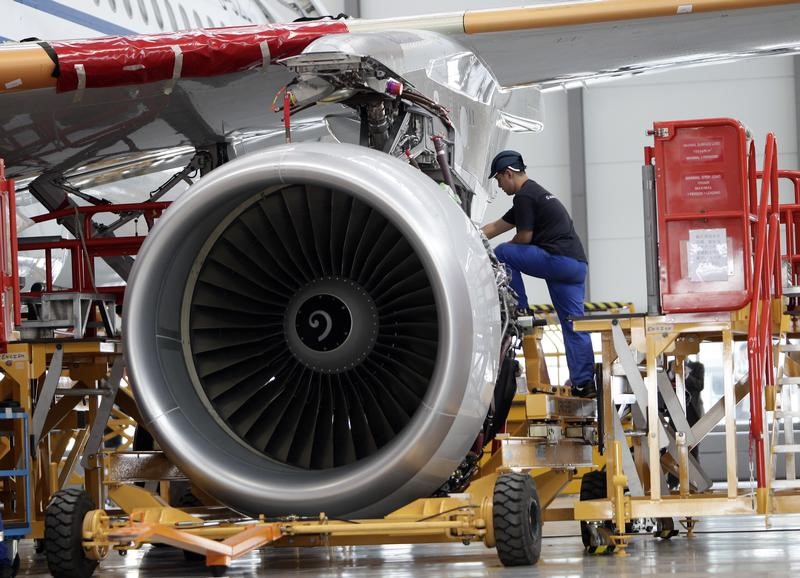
492, 474, 542, 566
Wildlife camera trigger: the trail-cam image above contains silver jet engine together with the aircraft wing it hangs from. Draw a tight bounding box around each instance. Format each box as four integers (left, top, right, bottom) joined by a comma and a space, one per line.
0, 0, 800, 568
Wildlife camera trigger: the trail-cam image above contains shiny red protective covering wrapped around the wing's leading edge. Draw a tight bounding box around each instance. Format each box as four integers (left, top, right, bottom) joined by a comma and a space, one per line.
52, 20, 348, 92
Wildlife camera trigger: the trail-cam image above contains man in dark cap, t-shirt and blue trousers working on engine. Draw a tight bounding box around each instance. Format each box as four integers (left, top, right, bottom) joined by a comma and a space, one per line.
481, 150, 597, 398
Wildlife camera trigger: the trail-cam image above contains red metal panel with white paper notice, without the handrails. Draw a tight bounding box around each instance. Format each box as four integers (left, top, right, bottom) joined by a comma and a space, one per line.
645, 118, 752, 313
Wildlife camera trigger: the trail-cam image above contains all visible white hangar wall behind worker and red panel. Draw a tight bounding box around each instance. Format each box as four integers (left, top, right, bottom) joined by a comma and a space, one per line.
340, 0, 800, 311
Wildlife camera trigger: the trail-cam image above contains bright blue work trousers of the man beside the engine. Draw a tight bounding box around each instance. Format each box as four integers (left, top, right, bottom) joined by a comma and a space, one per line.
494, 243, 594, 385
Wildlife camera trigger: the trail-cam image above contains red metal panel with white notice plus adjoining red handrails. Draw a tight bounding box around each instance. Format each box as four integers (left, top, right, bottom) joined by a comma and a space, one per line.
646, 118, 788, 488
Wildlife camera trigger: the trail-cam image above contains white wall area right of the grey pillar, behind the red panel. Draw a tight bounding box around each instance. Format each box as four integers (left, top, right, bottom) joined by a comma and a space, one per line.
583, 57, 800, 311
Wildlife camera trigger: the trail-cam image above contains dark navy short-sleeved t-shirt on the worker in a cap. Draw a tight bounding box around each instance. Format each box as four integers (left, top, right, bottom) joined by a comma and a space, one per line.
503, 179, 588, 263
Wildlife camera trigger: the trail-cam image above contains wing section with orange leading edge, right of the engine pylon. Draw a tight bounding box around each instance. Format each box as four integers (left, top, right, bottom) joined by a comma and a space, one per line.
454, 1, 800, 88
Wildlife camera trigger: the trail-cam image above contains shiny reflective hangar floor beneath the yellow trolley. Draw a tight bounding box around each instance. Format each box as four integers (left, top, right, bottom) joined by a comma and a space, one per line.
14, 516, 800, 578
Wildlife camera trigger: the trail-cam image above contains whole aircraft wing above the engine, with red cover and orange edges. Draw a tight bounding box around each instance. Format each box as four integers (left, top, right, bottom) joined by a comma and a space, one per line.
0, 0, 800, 177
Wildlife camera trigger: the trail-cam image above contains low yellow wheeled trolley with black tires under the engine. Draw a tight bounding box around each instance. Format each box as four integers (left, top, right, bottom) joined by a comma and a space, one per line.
40, 316, 597, 576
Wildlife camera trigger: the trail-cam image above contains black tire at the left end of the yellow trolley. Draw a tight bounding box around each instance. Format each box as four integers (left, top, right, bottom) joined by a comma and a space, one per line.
44, 488, 98, 578
